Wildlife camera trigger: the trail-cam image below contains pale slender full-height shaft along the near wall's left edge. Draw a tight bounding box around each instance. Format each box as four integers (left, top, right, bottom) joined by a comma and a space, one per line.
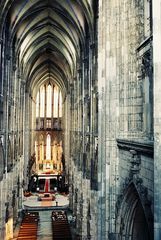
97, 1, 109, 240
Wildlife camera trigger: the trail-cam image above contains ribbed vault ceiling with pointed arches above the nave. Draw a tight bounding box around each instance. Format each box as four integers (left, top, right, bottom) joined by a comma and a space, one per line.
0, 0, 93, 97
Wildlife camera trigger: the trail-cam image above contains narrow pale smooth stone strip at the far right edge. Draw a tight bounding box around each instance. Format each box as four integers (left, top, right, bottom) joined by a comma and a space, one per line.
153, 0, 161, 240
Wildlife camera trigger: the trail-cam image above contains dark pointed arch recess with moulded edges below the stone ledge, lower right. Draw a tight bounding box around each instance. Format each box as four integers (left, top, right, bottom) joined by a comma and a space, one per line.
117, 182, 153, 240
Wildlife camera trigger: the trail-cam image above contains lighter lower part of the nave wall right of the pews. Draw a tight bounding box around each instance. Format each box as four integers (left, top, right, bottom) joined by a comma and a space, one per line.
70, 161, 97, 240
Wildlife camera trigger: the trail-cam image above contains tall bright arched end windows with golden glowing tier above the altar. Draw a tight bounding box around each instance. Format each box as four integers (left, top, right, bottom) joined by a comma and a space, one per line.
35, 82, 63, 173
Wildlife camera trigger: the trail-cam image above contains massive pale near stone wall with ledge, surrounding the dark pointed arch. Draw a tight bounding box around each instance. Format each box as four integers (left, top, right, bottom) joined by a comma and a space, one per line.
98, 0, 153, 239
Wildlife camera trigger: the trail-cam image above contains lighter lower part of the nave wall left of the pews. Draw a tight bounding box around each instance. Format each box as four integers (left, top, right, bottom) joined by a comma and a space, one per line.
0, 158, 23, 239
